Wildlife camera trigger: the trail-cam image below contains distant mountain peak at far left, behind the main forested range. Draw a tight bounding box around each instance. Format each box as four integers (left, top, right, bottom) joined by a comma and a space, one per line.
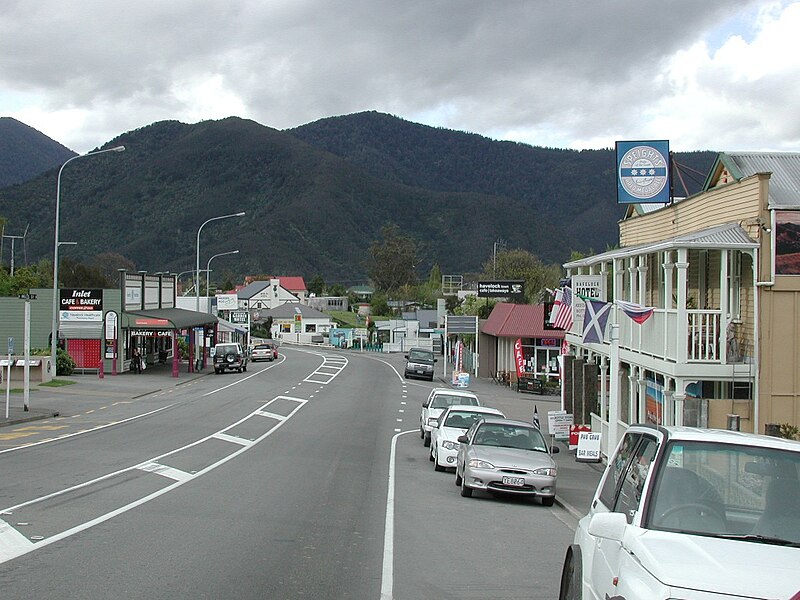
0, 117, 75, 188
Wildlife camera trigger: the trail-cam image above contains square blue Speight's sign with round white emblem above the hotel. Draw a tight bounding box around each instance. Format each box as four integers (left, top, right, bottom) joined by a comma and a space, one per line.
616, 140, 671, 204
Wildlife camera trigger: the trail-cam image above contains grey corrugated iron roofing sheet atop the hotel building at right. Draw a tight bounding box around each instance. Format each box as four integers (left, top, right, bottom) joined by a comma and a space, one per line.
720, 152, 800, 209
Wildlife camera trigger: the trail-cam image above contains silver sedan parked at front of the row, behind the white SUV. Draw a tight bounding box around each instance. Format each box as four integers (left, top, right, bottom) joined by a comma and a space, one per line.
456, 418, 558, 506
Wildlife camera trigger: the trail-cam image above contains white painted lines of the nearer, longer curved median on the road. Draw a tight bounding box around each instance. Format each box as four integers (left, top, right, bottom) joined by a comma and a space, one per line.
0, 396, 307, 564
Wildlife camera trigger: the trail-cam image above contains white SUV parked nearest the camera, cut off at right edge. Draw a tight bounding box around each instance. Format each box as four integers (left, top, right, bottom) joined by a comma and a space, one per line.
559, 425, 800, 600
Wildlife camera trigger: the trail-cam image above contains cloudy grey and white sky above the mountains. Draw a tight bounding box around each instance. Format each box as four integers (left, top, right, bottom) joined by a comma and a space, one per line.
0, 0, 800, 153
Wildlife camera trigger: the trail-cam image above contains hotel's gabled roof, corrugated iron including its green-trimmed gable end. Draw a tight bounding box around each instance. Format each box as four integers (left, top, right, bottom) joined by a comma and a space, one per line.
703, 152, 800, 209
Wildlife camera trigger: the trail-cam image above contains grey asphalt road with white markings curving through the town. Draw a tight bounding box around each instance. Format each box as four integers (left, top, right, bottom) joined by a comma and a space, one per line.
0, 347, 574, 600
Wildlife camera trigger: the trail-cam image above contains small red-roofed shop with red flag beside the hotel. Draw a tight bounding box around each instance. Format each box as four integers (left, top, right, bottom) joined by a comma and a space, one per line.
478, 302, 564, 382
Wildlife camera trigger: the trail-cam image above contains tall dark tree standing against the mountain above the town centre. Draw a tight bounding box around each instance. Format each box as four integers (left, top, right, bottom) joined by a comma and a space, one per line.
368, 223, 418, 292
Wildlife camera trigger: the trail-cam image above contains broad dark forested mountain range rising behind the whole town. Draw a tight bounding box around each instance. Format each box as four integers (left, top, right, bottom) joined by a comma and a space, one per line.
0, 113, 713, 282
